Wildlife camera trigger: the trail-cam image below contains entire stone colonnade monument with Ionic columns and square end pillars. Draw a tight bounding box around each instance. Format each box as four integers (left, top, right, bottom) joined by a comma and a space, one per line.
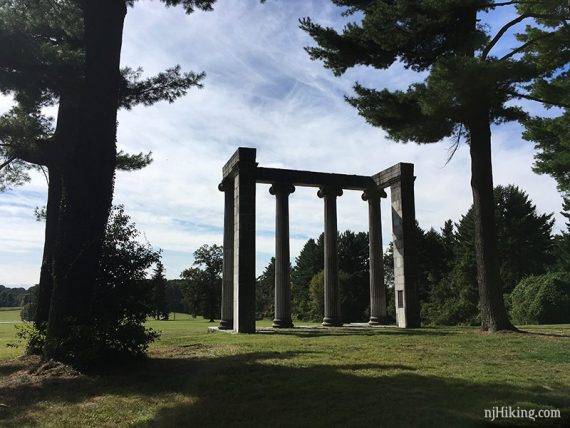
219, 147, 420, 333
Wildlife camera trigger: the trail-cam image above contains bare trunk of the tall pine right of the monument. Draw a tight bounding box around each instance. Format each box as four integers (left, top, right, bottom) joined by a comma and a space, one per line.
468, 109, 514, 332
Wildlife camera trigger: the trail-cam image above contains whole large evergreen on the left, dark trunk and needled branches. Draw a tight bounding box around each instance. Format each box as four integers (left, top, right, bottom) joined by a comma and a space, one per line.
0, 0, 215, 357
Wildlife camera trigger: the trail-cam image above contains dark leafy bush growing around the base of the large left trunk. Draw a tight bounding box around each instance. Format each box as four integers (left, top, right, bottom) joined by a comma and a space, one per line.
20, 206, 160, 368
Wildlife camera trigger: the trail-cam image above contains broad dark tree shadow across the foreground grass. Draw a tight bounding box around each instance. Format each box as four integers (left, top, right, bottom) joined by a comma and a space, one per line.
0, 351, 570, 427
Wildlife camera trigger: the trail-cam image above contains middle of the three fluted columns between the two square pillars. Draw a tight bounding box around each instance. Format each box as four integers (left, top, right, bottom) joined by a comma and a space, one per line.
317, 186, 342, 327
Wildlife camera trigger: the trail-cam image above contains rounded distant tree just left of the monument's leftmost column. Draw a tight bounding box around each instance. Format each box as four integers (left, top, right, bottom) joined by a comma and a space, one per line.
180, 244, 223, 322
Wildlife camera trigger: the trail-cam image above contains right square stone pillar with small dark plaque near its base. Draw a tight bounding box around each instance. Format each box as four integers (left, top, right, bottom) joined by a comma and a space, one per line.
391, 164, 420, 328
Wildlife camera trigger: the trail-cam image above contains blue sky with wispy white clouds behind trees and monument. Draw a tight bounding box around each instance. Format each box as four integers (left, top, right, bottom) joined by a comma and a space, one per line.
0, 0, 564, 286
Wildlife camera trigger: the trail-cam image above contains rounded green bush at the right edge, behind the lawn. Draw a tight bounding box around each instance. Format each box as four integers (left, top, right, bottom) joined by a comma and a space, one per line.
511, 272, 570, 324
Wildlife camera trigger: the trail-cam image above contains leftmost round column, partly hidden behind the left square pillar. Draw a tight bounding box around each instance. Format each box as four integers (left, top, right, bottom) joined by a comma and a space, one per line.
218, 178, 234, 330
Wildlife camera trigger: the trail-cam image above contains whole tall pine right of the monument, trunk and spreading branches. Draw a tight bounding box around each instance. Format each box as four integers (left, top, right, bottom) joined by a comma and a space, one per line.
301, 0, 570, 331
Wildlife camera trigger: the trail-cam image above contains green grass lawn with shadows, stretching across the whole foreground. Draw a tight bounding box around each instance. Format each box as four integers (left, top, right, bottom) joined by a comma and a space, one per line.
0, 314, 570, 428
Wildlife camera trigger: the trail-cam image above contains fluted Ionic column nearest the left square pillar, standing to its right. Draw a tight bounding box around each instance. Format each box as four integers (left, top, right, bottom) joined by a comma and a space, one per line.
269, 183, 295, 328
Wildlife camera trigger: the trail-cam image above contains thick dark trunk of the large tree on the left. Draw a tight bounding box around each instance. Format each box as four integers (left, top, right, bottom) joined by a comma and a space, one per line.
44, 0, 126, 358
